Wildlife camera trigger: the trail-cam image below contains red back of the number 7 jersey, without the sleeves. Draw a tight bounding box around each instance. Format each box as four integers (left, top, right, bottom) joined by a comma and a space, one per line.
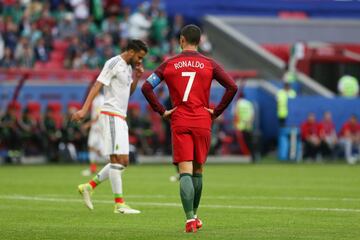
160, 51, 217, 128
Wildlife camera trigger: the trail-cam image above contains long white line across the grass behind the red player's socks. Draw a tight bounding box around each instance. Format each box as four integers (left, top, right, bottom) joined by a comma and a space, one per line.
0, 195, 360, 213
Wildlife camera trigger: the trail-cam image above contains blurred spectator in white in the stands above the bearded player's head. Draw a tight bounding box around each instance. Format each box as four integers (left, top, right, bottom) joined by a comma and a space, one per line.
129, 3, 151, 40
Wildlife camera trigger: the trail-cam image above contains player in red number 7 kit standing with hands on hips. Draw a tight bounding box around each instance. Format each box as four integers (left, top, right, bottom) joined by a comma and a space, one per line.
142, 25, 237, 232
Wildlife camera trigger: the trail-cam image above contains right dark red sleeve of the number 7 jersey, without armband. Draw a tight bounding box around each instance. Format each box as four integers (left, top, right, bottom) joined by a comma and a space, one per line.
212, 61, 237, 117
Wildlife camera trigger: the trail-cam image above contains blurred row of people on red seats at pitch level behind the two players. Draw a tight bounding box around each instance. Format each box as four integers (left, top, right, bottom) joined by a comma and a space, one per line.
0, 97, 239, 162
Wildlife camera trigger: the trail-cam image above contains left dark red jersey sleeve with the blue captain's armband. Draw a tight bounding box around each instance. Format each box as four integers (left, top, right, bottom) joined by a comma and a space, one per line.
141, 62, 167, 115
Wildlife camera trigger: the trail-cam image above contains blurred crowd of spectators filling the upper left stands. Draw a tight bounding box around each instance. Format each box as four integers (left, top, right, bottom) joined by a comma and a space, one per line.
0, 0, 212, 69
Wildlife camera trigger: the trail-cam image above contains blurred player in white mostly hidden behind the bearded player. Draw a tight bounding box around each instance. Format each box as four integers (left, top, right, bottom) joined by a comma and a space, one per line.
82, 92, 106, 176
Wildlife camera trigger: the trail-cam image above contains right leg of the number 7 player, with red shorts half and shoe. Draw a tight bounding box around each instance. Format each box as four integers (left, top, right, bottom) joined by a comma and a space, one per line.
192, 128, 211, 228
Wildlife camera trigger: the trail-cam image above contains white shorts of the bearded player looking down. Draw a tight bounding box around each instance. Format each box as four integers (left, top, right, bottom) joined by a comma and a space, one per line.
99, 114, 129, 155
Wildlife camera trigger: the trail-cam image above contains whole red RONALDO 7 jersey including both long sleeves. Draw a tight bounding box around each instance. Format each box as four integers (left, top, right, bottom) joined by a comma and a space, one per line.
142, 51, 237, 129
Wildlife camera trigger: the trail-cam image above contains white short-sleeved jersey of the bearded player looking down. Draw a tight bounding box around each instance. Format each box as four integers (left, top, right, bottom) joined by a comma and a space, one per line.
97, 55, 133, 117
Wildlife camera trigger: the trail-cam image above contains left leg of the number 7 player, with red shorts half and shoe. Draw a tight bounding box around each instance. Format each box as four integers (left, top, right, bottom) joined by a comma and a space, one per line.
172, 127, 197, 232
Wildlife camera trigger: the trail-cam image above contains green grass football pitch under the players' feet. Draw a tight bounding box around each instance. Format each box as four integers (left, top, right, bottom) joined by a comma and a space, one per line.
0, 164, 360, 240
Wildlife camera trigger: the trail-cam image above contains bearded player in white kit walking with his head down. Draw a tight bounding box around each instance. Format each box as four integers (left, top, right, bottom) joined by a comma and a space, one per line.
72, 40, 148, 214
